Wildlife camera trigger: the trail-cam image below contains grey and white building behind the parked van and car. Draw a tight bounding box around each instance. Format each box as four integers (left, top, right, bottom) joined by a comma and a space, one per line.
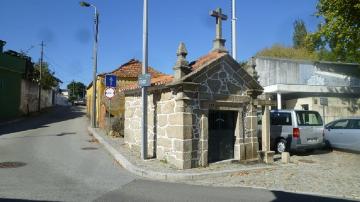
255, 57, 360, 122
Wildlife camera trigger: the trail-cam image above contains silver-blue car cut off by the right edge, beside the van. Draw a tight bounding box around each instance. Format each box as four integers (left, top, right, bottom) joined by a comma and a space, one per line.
324, 117, 360, 152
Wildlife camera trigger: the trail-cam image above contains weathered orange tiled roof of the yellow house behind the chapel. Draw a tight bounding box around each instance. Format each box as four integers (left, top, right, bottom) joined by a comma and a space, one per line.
100, 59, 164, 78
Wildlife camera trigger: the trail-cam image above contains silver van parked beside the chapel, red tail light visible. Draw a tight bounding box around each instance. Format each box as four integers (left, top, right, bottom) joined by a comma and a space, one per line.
258, 110, 325, 153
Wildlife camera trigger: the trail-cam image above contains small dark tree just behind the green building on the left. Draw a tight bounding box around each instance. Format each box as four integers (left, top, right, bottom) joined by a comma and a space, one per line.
32, 62, 62, 90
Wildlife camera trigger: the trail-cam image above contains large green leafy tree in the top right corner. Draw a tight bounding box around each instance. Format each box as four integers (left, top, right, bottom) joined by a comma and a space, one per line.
307, 0, 360, 62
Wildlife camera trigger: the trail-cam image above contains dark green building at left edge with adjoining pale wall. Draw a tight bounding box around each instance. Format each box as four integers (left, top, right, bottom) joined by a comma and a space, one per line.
0, 40, 60, 119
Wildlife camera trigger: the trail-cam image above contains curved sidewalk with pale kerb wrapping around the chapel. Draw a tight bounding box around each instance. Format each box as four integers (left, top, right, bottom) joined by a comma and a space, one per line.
88, 127, 292, 181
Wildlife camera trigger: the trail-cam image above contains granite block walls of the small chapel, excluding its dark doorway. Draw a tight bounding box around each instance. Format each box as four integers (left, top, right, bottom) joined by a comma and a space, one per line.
124, 62, 258, 169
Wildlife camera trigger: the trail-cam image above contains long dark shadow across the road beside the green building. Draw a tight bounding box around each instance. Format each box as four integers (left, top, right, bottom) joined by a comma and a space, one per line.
0, 106, 85, 136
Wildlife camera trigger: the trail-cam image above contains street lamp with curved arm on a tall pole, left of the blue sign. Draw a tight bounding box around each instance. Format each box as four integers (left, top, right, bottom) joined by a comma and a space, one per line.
80, 1, 99, 128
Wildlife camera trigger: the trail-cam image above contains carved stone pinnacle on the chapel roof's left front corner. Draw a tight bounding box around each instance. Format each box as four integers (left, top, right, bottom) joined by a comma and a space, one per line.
173, 42, 191, 81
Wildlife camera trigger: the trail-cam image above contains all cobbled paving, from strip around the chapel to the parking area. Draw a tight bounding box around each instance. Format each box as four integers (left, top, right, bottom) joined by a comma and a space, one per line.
97, 129, 360, 200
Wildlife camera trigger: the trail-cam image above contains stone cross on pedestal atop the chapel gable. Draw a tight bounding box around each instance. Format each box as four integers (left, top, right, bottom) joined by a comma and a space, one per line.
210, 8, 227, 52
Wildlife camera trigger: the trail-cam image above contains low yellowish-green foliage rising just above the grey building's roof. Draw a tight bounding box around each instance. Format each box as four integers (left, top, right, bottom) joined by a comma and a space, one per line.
256, 44, 318, 60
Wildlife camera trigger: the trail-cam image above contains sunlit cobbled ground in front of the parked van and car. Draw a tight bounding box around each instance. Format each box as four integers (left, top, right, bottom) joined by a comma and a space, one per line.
176, 151, 360, 200
